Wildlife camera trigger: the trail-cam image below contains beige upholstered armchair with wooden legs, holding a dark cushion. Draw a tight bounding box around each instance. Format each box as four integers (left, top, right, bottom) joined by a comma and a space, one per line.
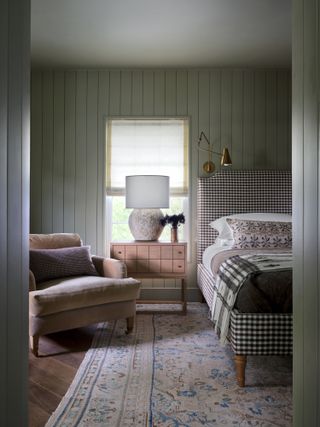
29, 233, 140, 356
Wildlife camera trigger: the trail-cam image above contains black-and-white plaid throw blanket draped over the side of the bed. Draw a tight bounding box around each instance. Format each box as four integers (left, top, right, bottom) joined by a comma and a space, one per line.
211, 253, 292, 345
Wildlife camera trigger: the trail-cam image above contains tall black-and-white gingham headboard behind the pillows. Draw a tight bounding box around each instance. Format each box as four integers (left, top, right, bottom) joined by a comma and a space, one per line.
197, 170, 292, 262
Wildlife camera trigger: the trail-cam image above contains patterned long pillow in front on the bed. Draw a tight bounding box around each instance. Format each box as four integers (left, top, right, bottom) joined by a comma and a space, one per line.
227, 218, 292, 248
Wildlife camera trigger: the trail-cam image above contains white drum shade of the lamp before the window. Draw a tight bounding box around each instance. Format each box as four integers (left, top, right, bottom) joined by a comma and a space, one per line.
126, 175, 169, 209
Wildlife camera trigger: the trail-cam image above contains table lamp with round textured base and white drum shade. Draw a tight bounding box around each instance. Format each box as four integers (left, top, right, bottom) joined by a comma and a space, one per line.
126, 175, 169, 240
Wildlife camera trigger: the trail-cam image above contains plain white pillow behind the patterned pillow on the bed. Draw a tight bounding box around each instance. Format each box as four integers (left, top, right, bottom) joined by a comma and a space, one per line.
209, 212, 292, 240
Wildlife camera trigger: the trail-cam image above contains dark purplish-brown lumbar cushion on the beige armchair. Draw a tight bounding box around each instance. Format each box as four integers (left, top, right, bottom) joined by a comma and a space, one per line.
30, 246, 98, 283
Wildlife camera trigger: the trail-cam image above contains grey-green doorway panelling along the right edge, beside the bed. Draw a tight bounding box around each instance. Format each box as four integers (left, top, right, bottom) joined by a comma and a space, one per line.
292, 0, 320, 427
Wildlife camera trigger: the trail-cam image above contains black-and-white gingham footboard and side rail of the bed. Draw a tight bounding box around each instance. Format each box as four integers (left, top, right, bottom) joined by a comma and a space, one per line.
197, 264, 292, 355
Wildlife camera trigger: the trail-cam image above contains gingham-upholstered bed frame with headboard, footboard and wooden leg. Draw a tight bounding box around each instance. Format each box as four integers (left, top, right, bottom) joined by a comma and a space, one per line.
197, 170, 292, 387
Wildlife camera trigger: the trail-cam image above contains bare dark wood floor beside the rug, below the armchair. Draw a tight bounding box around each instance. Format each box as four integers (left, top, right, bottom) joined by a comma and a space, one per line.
29, 326, 95, 427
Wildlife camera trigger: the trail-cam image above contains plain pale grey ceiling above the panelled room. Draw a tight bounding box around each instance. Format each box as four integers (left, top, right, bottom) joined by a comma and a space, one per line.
31, 0, 291, 68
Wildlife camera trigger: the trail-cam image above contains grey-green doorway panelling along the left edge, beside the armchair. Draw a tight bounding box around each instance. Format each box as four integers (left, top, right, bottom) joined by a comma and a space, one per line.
0, 0, 30, 427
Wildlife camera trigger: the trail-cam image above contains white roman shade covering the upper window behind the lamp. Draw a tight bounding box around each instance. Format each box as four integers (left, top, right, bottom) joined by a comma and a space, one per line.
106, 119, 189, 196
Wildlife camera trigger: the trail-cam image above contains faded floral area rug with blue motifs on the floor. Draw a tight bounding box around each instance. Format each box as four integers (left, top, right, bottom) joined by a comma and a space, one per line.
46, 303, 292, 427
